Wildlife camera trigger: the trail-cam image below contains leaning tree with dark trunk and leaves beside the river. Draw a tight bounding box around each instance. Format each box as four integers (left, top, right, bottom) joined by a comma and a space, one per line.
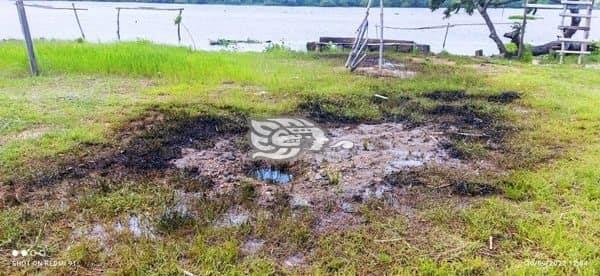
430, 0, 522, 56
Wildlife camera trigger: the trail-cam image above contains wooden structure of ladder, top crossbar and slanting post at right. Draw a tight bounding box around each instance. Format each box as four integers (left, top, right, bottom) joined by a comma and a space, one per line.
519, 0, 594, 64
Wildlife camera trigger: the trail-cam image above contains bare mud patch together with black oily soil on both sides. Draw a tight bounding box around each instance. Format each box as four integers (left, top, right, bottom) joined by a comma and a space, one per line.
2, 91, 515, 235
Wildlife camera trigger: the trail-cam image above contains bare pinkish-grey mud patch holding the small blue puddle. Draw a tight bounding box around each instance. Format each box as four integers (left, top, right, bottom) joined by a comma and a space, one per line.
170, 123, 468, 229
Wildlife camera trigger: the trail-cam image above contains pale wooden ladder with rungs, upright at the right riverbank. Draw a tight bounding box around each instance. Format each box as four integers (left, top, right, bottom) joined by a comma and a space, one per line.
558, 0, 594, 64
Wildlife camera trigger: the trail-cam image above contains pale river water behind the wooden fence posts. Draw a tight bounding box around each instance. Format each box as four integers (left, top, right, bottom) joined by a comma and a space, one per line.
0, 1, 600, 55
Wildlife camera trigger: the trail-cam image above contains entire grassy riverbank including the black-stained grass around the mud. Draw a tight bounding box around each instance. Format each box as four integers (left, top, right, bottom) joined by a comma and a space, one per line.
0, 41, 600, 275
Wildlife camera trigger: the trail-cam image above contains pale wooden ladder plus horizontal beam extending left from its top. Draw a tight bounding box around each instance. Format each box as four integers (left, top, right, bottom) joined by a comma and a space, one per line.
525, 0, 595, 64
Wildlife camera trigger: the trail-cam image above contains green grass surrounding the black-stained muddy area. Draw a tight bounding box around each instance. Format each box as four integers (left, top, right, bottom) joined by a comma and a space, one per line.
0, 41, 600, 275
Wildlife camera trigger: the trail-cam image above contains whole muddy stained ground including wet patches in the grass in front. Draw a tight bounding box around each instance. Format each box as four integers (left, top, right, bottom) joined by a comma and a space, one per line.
0, 91, 519, 266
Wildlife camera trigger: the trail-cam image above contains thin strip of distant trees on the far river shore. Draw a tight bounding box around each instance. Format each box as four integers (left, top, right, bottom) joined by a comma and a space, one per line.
59, 0, 524, 8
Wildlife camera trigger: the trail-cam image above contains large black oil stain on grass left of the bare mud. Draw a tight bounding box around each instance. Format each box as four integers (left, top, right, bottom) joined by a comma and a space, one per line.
18, 107, 247, 186
